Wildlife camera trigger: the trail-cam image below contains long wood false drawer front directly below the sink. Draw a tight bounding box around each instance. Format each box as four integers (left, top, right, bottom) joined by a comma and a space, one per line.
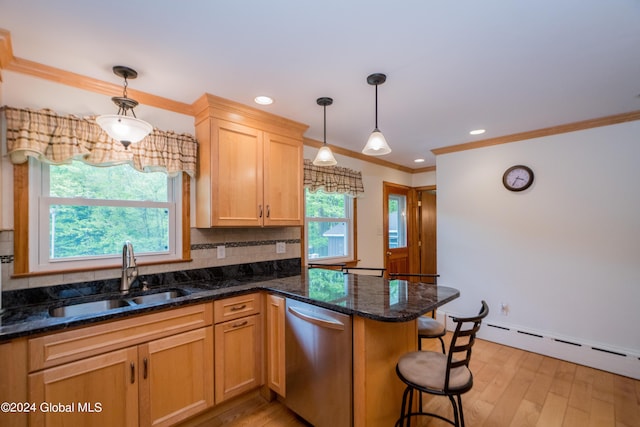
28, 304, 213, 372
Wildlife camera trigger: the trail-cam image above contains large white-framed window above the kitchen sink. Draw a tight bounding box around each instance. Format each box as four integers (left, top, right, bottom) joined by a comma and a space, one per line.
29, 160, 181, 271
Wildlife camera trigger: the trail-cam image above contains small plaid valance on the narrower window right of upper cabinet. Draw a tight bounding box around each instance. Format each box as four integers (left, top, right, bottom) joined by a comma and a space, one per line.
304, 159, 364, 197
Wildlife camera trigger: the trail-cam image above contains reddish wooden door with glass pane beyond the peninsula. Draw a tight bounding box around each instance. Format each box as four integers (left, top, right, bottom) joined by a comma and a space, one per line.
383, 182, 413, 273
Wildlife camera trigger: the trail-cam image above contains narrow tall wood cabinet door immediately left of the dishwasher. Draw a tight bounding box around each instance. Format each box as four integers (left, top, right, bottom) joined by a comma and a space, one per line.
267, 295, 286, 397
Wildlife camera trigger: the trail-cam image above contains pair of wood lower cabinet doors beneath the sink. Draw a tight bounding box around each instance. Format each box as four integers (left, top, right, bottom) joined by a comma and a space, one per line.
28, 326, 213, 427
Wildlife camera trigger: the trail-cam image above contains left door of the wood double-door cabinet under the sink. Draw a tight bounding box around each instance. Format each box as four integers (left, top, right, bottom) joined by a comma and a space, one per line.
28, 347, 138, 427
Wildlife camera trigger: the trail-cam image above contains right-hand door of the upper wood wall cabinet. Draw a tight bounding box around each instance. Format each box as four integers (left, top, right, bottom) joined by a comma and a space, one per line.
264, 133, 304, 225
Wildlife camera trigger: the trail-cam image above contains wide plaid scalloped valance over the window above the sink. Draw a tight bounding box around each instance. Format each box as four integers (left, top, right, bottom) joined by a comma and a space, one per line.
2, 106, 198, 177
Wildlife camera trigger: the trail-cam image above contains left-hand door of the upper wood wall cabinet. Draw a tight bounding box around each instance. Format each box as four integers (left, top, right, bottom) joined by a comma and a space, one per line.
210, 120, 265, 226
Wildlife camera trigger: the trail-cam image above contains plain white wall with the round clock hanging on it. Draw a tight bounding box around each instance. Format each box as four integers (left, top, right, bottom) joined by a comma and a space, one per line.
437, 121, 640, 377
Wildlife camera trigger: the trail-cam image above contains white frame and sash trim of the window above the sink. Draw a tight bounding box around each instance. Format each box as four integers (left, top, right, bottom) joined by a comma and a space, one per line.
29, 158, 182, 272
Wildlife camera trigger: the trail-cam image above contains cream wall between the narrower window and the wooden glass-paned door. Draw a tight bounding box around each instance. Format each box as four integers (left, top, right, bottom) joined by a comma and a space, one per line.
304, 146, 435, 267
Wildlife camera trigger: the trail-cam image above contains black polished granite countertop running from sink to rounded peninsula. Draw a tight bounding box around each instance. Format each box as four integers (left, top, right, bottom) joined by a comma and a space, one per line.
0, 268, 460, 342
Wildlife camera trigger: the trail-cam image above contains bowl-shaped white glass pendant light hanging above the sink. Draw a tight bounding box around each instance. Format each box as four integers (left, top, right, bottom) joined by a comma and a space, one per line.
96, 65, 153, 150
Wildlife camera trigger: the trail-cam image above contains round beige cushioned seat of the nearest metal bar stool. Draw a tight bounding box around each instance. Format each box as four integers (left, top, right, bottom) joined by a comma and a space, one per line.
397, 351, 473, 394
